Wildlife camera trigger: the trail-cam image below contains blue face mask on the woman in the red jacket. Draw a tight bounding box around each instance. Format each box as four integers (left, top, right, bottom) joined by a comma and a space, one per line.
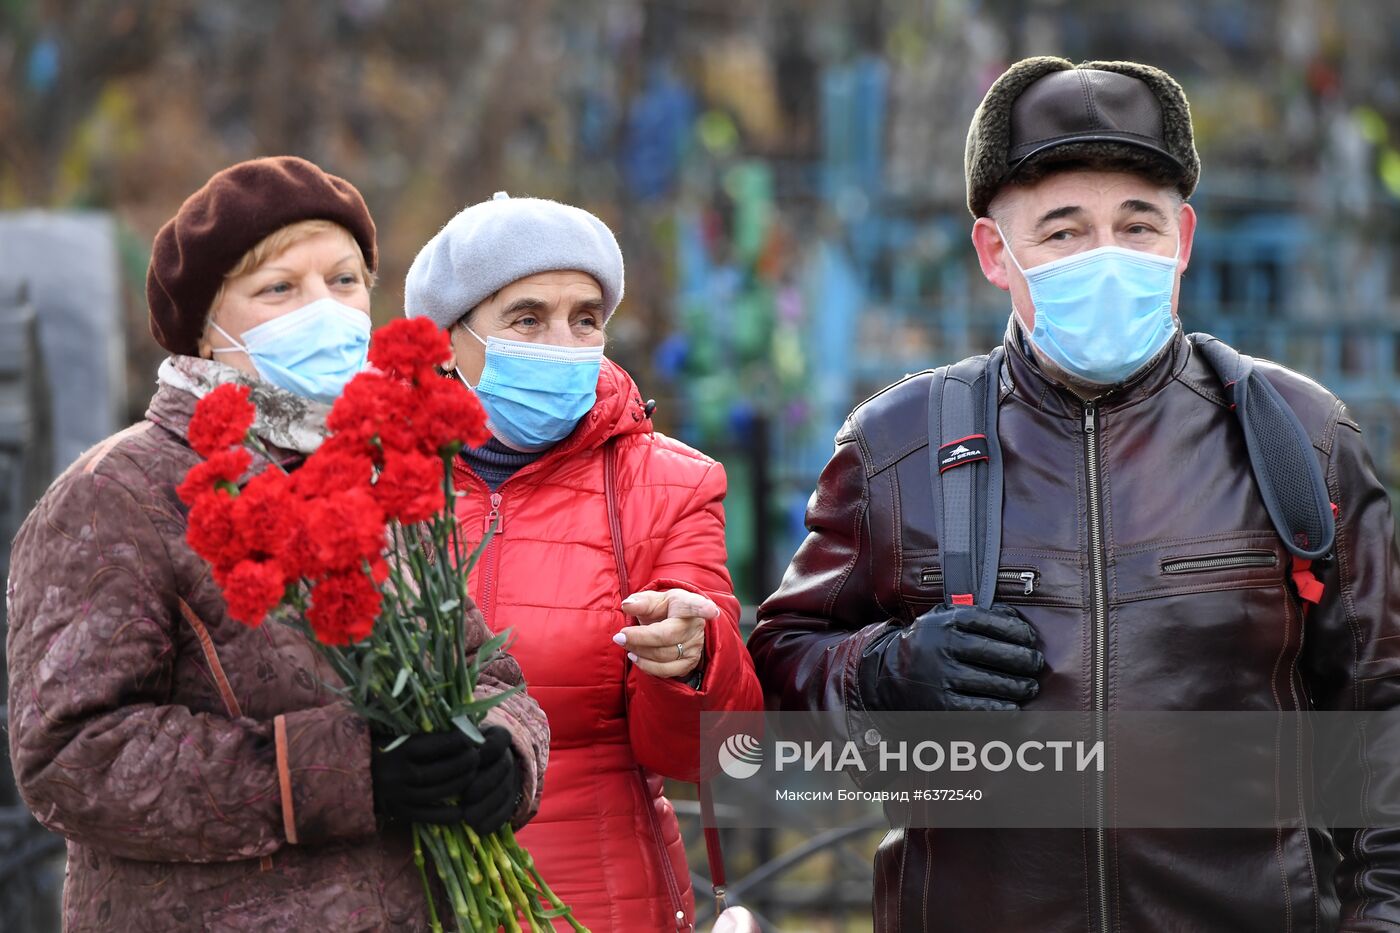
456, 328, 603, 452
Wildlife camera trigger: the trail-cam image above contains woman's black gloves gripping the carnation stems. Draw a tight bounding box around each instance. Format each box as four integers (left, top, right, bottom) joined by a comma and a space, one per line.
370, 726, 522, 835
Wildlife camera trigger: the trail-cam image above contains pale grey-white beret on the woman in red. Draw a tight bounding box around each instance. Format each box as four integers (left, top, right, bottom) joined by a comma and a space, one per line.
403, 191, 623, 328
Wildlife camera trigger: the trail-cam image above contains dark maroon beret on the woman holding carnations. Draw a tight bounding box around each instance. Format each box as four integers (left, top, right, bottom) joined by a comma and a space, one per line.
146, 156, 378, 356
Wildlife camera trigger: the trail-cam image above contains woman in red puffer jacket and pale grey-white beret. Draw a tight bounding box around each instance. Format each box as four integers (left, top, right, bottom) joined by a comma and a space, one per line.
405, 192, 763, 933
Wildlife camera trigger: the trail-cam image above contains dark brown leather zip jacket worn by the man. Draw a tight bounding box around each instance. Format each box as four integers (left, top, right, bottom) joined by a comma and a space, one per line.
749, 335, 1400, 933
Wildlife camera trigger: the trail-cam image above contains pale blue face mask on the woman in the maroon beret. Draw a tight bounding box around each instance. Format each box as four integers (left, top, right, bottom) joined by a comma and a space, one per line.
210, 298, 370, 403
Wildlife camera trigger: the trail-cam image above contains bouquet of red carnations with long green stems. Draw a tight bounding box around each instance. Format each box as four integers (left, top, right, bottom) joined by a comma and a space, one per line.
179, 318, 584, 932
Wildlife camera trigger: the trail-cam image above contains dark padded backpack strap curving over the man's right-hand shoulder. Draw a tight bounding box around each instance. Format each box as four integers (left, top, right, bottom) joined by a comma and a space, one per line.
1189, 333, 1337, 560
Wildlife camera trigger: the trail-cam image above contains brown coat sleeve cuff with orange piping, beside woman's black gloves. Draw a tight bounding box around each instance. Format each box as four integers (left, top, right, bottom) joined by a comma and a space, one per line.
273, 705, 375, 845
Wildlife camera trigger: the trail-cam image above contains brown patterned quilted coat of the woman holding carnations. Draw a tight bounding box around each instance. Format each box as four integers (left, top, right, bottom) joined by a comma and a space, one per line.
8, 375, 549, 933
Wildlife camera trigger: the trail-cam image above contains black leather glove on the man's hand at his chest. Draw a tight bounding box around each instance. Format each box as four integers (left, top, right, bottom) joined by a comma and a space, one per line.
860, 605, 1044, 712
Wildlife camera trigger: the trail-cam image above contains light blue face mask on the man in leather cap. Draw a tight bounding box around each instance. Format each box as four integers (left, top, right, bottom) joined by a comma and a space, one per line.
997, 227, 1182, 385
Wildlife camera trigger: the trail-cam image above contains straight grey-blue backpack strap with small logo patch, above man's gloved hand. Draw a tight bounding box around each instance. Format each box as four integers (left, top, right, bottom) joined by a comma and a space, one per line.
928, 347, 1002, 608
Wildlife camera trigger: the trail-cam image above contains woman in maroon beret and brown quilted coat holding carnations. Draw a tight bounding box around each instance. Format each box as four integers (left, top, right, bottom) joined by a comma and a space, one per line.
8, 157, 549, 932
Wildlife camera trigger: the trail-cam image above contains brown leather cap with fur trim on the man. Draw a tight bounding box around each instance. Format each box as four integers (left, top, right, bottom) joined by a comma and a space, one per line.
963, 56, 1201, 217
